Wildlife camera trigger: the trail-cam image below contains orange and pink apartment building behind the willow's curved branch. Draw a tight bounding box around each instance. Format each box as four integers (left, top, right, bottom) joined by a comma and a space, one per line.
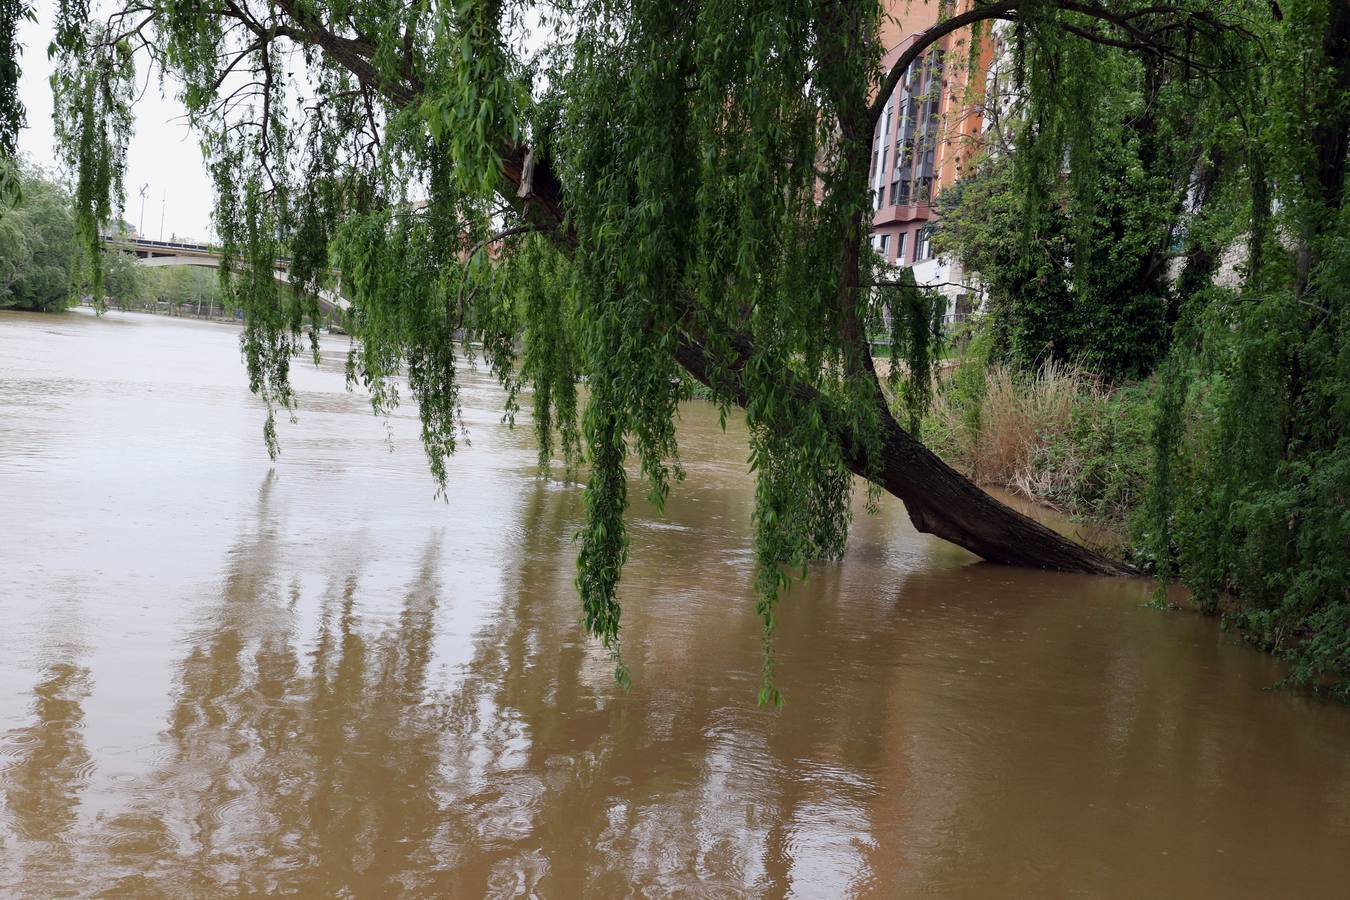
871, 0, 994, 320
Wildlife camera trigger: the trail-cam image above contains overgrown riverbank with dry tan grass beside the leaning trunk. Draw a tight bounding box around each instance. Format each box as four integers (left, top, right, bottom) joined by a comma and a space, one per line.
922, 337, 1350, 703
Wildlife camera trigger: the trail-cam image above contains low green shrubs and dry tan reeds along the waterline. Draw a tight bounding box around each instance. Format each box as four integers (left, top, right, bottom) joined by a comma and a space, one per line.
923, 322, 1350, 702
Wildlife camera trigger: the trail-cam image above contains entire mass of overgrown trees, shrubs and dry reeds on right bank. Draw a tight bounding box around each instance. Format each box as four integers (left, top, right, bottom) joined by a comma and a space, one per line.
930, 0, 1350, 700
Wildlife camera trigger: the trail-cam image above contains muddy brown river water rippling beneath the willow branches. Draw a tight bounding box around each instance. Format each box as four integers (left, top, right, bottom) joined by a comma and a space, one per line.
0, 307, 1350, 897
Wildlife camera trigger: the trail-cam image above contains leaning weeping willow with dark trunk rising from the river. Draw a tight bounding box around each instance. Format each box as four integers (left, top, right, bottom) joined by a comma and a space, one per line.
36, 0, 1263, 699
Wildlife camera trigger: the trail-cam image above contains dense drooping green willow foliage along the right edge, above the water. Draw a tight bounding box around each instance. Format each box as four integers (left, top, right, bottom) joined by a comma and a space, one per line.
1150, 0, 1350, 702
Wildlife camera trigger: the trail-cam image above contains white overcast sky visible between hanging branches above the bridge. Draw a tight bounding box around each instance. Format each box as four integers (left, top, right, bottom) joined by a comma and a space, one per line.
19, 0, 213, 240
